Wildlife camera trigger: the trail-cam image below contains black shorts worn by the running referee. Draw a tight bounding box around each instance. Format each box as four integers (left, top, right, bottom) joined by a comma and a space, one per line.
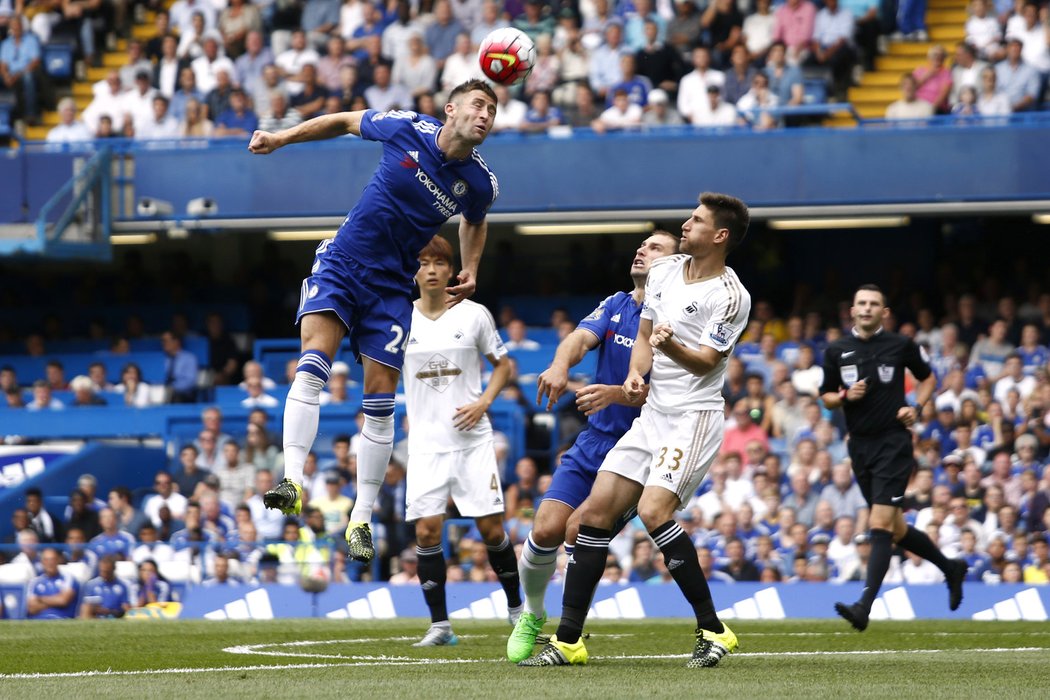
848, 430, 916, 508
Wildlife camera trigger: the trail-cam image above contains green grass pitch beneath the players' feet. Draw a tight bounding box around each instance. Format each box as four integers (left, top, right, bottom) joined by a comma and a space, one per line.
0, 620, 1050, 700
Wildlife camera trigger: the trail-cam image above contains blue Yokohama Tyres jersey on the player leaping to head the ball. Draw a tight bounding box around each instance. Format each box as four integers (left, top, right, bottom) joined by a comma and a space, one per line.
332, 109, 500, 281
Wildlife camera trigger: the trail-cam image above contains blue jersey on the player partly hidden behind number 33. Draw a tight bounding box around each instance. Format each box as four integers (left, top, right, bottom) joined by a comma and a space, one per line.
579, 292, 642, 436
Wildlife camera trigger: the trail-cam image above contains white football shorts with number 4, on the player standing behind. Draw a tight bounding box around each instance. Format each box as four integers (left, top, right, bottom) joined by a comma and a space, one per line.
405, 440, 503, 523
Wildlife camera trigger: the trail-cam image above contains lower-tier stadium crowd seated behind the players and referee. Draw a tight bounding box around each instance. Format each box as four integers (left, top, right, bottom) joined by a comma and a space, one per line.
0, 272, 1050, 614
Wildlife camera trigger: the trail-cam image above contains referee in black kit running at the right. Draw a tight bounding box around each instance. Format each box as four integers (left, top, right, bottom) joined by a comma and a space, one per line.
820, 284, 967, 632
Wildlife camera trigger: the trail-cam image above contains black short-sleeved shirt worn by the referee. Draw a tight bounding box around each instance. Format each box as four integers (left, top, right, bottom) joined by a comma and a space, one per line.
820, 328, 930, 437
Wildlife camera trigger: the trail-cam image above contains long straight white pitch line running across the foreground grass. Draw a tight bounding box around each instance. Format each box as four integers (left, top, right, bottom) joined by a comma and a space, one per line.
0, 646, 1050, 680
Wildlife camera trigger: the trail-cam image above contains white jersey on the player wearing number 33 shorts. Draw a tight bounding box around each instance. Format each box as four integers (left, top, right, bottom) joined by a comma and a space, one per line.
642, 255, 751, 412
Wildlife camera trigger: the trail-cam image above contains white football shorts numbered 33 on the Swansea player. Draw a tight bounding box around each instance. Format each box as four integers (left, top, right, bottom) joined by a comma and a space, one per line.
600, 406, 726, 508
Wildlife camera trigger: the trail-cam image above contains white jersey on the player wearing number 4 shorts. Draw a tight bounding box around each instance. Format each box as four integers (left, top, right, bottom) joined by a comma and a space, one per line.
402, 300, 507, 454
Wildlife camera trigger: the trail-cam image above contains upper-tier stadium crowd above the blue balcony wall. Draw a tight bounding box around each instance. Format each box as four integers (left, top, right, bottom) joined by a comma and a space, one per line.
0, 0, 1050, 142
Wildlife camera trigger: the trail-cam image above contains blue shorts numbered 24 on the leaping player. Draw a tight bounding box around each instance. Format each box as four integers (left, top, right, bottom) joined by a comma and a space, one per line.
295, 241, 412, 369
